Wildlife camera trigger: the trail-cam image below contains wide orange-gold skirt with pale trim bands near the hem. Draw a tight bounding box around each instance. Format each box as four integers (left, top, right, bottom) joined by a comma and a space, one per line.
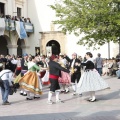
19, 71, 42, 94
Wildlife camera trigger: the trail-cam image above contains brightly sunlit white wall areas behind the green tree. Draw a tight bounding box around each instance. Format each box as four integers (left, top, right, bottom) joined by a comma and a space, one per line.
35, 0, 118, 58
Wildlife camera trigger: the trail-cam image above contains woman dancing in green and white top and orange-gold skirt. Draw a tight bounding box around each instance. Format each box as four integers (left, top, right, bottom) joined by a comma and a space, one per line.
19, 56, 42, 100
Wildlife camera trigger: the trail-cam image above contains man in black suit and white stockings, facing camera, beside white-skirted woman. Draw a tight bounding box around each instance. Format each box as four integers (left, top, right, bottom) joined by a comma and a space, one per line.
65, 53, 81, 95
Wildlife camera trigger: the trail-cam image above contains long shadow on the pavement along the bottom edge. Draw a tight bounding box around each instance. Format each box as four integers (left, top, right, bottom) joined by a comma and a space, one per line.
0, 110, 120, 120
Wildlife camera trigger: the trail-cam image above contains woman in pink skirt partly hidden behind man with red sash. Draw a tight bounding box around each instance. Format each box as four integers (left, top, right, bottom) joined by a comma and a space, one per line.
58, 55, 71, 93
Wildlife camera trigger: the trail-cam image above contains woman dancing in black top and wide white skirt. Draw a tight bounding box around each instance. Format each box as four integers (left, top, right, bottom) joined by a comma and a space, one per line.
77, 52, 109, 102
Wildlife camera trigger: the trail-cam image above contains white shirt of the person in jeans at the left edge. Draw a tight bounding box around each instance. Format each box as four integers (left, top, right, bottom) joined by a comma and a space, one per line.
0, 69, 13, 85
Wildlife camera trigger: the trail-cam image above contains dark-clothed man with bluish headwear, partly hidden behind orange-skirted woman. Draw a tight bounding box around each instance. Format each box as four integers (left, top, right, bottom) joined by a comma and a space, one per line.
20, 53, 28, 96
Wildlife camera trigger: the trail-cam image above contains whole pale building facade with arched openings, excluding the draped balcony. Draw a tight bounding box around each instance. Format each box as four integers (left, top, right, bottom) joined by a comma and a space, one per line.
0, 0, 119, 58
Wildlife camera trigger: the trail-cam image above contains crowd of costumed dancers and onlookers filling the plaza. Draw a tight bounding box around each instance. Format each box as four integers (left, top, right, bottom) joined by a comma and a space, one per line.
0, 52, 110, 105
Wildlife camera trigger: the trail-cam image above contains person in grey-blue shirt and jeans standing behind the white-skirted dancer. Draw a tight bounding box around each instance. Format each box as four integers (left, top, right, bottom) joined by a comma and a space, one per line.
95, 53, 103, 75
